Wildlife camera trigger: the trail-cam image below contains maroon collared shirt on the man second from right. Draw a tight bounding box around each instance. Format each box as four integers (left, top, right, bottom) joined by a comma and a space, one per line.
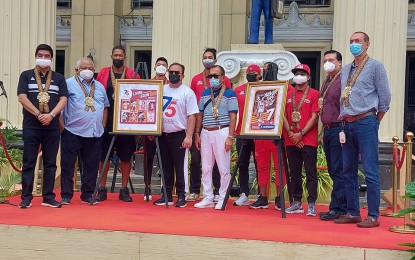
320, 75, 341, 124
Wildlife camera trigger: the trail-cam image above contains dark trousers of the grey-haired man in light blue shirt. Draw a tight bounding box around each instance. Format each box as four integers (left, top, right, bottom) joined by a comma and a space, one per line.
61, 129, 102, 200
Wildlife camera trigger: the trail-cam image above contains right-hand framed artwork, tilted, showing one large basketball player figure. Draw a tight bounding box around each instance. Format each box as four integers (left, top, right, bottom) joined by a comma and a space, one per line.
240, 81, 288, 139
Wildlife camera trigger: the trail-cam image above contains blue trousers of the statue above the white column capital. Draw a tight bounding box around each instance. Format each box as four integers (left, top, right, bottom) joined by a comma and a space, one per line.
249, 0, 274, 44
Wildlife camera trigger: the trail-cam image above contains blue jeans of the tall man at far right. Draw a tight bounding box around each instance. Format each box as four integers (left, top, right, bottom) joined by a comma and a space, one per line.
343, 115, 380, 219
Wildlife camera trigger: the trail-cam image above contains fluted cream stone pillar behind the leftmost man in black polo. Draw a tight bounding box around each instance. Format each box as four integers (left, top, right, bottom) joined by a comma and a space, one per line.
0, 0, 56, 128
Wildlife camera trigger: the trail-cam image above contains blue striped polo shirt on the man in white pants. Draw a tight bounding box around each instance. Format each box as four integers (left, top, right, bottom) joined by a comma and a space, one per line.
199, 88, 238, 127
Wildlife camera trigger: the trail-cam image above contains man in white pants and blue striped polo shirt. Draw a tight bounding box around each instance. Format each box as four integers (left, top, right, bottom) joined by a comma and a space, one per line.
195, 65, 238, 209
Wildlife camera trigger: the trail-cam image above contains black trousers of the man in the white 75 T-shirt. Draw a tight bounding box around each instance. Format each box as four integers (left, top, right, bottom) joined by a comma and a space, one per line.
159, 130, 187, 198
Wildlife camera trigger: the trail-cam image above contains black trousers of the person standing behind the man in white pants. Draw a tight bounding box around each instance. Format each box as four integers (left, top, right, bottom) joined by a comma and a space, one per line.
189, 138, 220, 195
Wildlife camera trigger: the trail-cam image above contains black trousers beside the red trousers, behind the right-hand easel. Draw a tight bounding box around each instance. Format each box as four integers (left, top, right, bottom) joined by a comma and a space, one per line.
236, 139, 258, 196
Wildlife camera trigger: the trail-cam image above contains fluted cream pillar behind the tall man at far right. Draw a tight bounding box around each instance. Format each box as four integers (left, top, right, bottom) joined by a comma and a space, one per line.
333, 0, 408, 142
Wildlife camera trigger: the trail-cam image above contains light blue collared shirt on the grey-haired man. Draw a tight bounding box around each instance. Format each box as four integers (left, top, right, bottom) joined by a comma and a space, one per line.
62, 76, 110, 137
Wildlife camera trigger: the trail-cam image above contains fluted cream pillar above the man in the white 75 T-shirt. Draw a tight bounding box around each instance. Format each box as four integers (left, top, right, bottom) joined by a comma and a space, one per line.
151, 0, 220, 84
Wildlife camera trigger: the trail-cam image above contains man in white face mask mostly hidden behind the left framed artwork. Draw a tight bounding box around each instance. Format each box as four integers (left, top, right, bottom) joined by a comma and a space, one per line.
144, 57, 169, 201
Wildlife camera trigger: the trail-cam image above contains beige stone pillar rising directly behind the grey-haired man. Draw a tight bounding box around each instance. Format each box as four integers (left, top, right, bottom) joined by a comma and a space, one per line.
70, 0, 122, 75
